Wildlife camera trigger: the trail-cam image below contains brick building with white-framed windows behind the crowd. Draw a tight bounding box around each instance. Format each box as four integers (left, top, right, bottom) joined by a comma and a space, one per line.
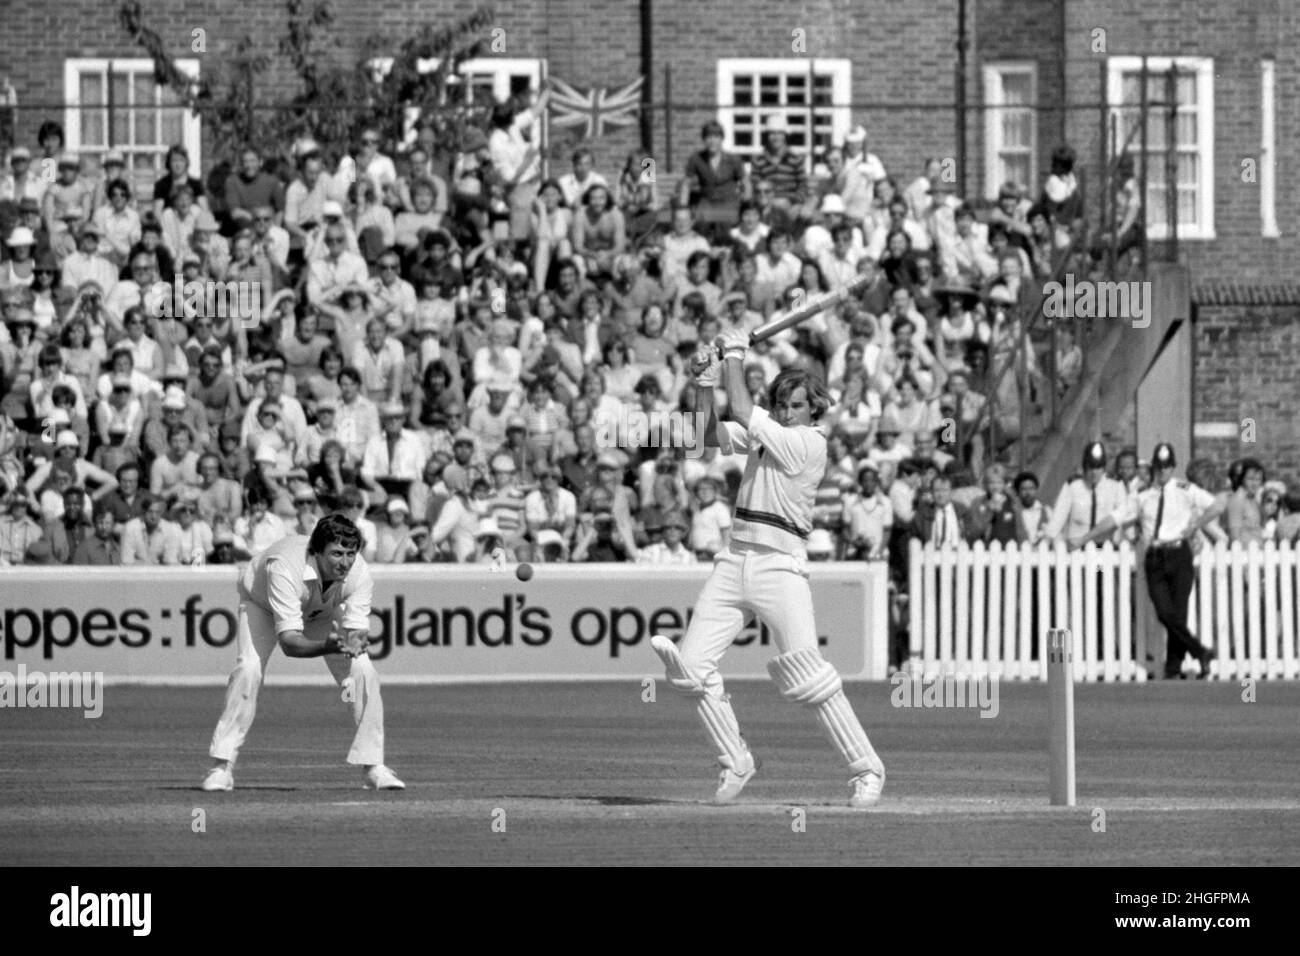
0, 0, 1300, 477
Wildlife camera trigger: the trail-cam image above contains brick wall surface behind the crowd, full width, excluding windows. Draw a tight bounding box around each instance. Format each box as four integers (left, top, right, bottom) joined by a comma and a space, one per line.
0, 0, 1300, 281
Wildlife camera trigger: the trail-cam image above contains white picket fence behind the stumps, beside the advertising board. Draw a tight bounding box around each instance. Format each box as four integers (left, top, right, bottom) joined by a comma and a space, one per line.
909, 541, 1300, 682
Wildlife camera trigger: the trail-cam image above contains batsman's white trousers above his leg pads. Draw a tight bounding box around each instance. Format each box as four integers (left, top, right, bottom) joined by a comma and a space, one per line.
677, 544, 818, 697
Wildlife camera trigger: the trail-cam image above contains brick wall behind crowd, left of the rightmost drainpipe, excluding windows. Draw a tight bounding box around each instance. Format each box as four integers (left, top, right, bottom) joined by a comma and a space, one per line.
0, 0, 978, 199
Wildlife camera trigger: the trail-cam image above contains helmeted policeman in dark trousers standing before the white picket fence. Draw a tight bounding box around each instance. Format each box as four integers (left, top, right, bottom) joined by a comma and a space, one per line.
1102, 442, 1222, 678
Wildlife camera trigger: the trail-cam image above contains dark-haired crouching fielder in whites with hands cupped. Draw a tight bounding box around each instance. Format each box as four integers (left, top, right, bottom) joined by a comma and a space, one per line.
203, 514, 406, 790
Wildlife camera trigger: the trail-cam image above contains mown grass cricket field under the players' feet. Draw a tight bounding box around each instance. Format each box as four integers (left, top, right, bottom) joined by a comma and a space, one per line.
0, 681, 1300, 866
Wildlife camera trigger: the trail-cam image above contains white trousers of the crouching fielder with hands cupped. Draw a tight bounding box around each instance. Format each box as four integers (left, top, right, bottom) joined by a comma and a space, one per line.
208, 601, 384, 766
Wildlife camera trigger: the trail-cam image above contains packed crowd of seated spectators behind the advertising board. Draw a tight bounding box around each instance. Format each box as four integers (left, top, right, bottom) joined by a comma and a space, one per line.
0, 101, 1269, 564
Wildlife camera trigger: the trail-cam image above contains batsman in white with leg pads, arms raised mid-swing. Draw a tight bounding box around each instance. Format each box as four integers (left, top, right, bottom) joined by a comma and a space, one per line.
650, 332, 885, 808
